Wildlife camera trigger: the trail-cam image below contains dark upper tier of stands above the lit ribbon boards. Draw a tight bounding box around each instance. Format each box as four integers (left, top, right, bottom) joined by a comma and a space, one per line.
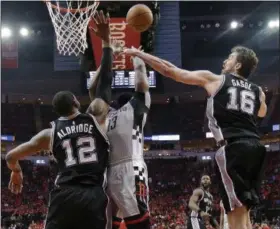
1, 90, 280, 141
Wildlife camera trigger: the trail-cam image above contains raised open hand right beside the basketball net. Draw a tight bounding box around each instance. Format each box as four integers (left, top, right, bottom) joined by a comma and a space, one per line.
90, 10, 110, 43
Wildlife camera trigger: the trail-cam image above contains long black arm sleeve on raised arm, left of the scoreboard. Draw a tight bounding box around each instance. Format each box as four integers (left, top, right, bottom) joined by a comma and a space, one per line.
95, 47, 113, 104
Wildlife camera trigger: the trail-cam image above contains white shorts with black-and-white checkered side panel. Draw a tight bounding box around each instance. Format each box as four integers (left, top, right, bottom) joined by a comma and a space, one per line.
108, 160, 149, 218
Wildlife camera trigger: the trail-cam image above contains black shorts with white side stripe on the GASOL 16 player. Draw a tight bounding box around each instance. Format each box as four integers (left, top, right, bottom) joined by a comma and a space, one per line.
215, 139, 266, 213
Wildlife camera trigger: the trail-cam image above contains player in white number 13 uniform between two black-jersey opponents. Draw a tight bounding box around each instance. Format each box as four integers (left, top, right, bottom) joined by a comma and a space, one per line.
89, 11, 151, 229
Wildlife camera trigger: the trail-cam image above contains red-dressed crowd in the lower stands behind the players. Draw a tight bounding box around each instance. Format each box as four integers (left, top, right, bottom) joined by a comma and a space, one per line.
1, 149, 280, 229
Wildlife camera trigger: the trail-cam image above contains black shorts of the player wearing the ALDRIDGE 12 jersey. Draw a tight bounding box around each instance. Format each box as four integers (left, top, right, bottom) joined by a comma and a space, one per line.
45, 185, 112, 229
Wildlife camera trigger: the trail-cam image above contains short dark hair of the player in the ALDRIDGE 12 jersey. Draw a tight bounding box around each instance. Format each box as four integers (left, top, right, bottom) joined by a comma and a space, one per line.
52, 91, 75, 116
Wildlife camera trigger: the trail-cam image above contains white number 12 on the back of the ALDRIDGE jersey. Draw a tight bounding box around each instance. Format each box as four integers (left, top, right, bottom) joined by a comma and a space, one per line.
62, 137, 98, 167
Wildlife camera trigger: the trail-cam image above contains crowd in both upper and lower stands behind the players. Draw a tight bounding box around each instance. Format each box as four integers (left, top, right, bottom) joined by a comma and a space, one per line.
1, 94, 280, 229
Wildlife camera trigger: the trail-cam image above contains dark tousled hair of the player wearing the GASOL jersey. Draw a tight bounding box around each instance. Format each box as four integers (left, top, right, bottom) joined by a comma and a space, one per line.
231, 45, 259, 78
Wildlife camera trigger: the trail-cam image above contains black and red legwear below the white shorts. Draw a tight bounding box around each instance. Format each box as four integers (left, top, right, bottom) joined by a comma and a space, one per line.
124, 212, 151, 229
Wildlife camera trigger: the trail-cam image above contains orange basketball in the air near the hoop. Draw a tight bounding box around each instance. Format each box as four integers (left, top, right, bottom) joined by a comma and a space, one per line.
126, 4, 153, 32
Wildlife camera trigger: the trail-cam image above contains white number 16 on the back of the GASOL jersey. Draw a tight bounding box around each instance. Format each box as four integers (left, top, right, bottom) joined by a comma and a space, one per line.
227, 87, 256, 115
